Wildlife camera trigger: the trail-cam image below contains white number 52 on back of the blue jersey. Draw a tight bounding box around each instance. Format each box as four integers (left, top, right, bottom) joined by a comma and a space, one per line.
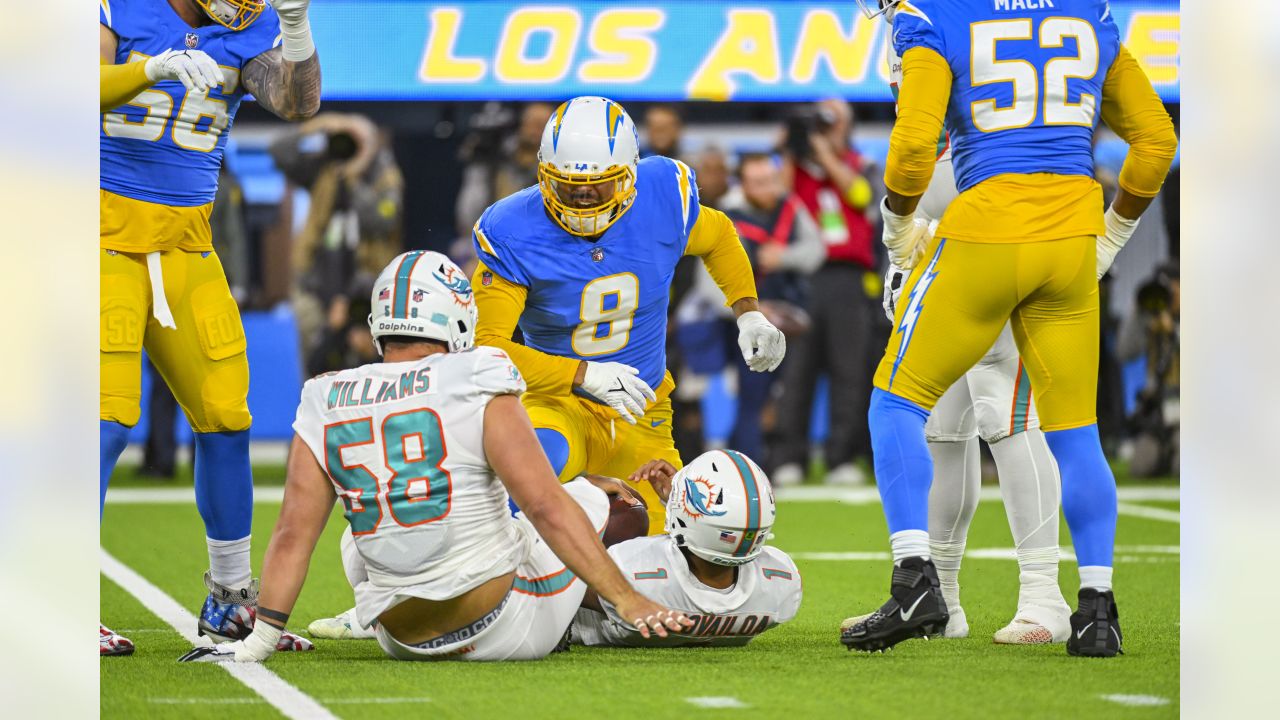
969, 18, 1098, 132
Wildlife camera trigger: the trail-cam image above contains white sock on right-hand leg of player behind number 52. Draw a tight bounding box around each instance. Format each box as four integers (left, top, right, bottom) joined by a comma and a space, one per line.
988, 429, 1061, 550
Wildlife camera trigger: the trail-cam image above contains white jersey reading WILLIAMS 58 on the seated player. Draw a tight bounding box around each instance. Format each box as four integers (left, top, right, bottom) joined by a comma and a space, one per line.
293, 347, 531, 604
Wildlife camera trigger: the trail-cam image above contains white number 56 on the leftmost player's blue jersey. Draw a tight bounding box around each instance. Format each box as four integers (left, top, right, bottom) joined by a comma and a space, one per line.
102, 51, 239, 152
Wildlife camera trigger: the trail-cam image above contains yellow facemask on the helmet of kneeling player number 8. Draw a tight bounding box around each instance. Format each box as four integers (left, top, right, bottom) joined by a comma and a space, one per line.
538, 163, 636, 237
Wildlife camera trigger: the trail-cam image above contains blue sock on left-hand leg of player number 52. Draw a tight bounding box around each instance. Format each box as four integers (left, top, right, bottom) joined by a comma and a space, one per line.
867, 388, 933, 536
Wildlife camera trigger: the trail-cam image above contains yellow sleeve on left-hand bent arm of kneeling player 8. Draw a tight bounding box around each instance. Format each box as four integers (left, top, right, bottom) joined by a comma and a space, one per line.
471, 259, 580, 395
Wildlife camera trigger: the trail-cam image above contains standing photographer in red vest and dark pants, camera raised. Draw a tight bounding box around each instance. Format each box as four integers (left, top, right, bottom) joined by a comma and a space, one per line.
771, 99, 883, 484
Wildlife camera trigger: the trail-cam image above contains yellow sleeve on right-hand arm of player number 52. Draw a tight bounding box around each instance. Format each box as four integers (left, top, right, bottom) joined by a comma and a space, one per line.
1102, 45, 1178, 197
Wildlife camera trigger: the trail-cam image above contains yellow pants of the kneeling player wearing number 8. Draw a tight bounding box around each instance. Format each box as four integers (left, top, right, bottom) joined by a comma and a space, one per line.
524, 373, 684, 536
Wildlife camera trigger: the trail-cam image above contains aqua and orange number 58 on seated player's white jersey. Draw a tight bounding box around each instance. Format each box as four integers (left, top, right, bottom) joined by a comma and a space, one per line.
324, 409, 453, 536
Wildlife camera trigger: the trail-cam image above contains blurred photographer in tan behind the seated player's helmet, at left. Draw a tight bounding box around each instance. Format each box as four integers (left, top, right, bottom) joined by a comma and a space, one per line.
269, 113, 404, 355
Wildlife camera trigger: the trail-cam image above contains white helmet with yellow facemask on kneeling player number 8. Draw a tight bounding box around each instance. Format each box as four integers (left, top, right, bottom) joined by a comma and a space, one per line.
538, 96, 640, 237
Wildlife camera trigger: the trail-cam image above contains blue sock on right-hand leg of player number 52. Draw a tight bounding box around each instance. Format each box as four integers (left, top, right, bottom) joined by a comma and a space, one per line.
1044, 424, 1116, 568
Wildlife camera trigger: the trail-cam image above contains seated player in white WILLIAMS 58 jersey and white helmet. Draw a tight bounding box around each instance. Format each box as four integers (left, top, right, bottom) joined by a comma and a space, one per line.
183, 251, 691, 662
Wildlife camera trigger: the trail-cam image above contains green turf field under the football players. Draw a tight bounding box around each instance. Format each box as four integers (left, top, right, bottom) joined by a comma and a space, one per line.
101, 473, 1180, 720
